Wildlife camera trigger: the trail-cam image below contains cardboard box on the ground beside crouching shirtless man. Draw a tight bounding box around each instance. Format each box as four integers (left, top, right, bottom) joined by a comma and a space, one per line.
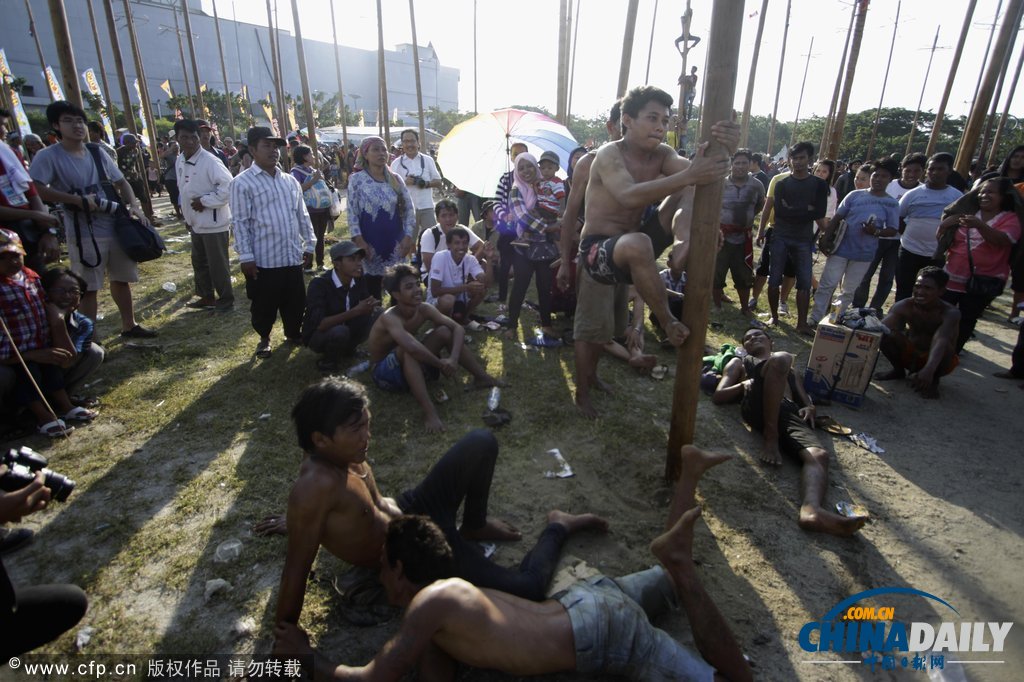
804, 323, 882, 408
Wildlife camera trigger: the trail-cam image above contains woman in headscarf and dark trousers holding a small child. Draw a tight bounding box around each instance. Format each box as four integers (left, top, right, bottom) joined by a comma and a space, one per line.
509, 153, 558, 337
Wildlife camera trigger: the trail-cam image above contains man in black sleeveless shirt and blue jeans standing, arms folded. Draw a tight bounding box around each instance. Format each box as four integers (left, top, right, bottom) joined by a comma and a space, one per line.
768, 142, 828, 336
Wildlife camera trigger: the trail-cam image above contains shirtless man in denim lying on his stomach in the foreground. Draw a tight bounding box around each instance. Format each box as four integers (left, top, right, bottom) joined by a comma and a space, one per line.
274, 445, 753, 681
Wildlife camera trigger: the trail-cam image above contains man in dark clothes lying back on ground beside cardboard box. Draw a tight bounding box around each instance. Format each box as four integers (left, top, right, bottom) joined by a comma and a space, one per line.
711, 329, 867, 536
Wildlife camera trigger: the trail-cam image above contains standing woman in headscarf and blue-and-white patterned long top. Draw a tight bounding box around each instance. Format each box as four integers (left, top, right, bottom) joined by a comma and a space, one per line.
348, 137, 416, 300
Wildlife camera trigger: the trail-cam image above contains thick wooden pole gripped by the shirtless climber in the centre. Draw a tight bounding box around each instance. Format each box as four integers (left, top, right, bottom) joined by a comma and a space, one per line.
665, 0, 743, 479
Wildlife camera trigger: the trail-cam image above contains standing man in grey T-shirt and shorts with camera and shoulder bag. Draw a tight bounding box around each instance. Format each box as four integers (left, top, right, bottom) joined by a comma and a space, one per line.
30, 100, 157, 338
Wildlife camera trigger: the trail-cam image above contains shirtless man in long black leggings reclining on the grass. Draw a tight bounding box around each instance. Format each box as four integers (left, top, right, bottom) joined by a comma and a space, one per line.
256, 374, 607, 623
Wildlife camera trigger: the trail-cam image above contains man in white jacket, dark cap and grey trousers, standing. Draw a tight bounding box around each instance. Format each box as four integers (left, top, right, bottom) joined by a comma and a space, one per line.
174, 120, 234, 310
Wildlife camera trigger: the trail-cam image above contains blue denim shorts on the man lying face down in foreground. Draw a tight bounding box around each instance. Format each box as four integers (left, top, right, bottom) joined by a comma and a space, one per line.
554, 566, 715, 682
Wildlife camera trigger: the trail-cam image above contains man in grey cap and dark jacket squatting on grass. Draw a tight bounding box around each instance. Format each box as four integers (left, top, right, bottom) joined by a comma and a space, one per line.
302, 240, 380, 372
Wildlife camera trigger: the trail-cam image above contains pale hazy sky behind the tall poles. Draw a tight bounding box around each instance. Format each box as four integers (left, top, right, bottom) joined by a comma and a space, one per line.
211, 0, 1024, 120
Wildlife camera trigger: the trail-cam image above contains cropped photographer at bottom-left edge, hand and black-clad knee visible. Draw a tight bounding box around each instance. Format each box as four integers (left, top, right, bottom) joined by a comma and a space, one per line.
0, 465, 89, 664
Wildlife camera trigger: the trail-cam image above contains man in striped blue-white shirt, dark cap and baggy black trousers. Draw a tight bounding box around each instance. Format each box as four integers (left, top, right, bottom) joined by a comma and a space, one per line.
229, 126, 316, 358
